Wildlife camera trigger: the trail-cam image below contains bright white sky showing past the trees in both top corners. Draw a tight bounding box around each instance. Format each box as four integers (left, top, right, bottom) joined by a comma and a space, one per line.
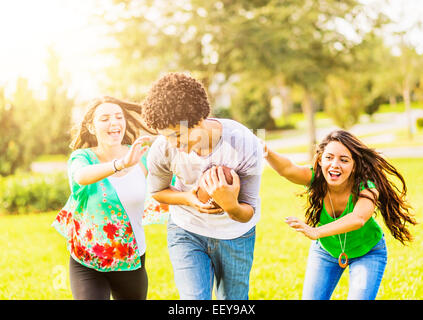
0, 0, 423, 98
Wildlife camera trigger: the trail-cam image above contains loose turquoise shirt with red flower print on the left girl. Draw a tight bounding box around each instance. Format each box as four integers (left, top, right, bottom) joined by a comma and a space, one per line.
53, 148, 141, 271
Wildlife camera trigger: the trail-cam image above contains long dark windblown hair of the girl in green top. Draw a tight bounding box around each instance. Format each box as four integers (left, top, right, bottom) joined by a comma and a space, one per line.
305, 130, 417, 244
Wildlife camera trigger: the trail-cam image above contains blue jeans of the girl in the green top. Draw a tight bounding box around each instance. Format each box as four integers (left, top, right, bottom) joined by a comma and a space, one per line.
302, 236, 387, 300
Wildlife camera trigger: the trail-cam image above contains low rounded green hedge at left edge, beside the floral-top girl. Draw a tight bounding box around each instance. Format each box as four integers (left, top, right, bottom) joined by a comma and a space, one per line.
0, 172, 70, 214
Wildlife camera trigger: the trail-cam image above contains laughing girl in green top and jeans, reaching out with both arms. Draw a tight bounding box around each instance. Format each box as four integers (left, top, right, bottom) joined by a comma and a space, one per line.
265, 130, 416, 300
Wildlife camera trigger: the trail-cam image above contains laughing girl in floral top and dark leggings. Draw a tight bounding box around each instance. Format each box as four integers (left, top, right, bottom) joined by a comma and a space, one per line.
53, 97, 156, 299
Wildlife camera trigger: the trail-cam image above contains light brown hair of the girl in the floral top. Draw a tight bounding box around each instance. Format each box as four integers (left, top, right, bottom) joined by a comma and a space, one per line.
70, 96, 157, 150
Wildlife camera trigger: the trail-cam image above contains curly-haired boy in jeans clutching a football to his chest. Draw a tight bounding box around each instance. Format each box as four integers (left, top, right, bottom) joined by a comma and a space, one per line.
142, 73, 263, 300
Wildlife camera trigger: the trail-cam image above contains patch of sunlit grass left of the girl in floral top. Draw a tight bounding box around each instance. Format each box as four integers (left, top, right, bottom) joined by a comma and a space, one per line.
0, 213, 72, 299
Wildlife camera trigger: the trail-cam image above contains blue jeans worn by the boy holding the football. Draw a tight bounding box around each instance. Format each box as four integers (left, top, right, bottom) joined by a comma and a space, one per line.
167, 219, 256, 300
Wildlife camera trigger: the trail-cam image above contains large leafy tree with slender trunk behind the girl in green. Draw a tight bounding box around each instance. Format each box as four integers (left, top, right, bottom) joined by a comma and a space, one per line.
212, 0, 380, 157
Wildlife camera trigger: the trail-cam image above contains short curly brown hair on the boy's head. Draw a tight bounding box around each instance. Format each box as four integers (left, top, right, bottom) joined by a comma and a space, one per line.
142, 72, 210, 130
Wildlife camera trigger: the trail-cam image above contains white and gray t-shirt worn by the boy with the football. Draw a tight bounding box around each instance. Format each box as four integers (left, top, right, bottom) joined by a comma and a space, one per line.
147, 118, 263, 239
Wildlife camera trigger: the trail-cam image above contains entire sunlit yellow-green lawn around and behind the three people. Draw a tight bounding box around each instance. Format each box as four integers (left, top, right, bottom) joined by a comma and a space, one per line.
0, 159, 423, 300
